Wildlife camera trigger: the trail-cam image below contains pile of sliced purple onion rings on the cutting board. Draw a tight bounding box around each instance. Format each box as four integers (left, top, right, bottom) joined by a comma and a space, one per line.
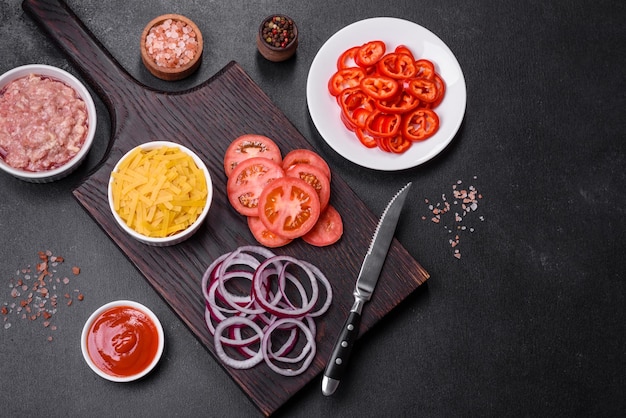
202, 246, 332, 376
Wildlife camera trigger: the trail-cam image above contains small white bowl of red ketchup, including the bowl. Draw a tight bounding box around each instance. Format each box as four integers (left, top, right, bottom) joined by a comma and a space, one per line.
80, 300, 165, 382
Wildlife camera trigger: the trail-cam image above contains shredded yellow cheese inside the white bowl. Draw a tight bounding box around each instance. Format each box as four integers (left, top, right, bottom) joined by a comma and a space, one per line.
111, 146, 208, 238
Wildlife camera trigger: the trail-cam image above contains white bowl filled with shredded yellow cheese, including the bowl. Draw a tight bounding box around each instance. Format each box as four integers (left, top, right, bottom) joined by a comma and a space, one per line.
108, 141, 213, 247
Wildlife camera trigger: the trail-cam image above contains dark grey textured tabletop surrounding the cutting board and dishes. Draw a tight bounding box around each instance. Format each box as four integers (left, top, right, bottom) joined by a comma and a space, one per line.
0, 0, 626, 417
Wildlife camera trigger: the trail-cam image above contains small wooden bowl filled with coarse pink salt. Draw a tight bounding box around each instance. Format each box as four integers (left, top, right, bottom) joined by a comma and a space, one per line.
141, 14, 203, 81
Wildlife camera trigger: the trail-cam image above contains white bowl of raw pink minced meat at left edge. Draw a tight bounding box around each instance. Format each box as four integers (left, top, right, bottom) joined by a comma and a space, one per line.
0, 64, 97, 183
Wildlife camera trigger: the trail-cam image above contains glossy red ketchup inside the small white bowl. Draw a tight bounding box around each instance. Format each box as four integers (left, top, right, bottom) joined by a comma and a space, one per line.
87, 306, 159, 377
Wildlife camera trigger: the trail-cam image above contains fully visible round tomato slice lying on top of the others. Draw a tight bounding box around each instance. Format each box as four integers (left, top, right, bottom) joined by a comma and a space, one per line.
258, 177, 320, 239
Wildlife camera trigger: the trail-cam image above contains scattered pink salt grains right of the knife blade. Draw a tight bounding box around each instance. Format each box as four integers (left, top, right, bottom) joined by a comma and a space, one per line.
422, 176, 485, 259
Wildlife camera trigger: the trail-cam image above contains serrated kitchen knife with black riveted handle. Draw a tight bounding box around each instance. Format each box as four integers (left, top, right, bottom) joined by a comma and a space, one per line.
322, 183, 411, 396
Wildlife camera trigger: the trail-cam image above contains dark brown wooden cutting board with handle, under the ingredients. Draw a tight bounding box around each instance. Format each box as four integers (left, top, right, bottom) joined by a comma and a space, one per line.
23, 0, 428, 416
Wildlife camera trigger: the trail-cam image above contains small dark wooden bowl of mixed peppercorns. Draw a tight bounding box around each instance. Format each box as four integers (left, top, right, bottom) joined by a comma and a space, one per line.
256, 15, 298, 62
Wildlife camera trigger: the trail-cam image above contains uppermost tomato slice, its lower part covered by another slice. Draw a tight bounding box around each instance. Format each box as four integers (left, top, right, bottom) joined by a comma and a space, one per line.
224, 134, 282, 177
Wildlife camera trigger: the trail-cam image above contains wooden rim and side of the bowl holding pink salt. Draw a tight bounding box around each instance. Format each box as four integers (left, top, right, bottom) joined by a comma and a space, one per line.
141, 14, 204, 81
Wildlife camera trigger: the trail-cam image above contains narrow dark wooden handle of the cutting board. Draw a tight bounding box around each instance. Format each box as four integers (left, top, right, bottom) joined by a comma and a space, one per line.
22, 0, 139, 112
